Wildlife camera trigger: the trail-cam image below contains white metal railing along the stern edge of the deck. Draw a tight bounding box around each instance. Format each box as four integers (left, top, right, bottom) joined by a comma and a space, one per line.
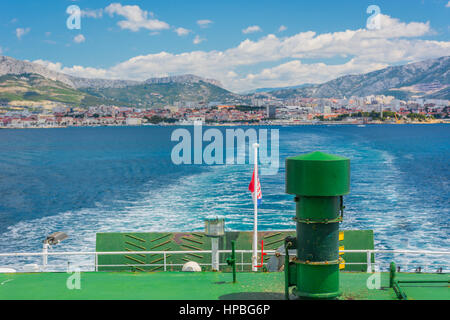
0, 250, 450, 273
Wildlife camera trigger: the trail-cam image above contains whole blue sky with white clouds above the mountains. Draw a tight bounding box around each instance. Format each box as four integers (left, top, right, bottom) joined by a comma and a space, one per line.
0, 0, 450, 91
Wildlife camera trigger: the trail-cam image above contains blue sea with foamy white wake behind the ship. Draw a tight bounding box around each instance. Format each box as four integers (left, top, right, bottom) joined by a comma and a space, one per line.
0, 125, 450, 271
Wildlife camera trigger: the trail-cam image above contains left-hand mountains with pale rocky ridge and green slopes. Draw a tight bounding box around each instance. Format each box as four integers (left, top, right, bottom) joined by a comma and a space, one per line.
0, 56, 239, 108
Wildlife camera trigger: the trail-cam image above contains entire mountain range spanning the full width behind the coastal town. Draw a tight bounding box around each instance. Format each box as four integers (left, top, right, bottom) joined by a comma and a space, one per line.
0, 56, 450, 108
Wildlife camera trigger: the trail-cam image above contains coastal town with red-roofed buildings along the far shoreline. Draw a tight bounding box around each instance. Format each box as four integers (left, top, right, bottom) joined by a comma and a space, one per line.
0, 95, 450, 129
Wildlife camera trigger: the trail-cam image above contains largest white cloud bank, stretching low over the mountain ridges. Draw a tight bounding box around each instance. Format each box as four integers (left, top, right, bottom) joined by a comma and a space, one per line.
36, 16, 450, 91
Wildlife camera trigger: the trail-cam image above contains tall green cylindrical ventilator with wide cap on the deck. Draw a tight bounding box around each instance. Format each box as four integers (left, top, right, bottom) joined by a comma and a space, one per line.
285, 152, 350, 299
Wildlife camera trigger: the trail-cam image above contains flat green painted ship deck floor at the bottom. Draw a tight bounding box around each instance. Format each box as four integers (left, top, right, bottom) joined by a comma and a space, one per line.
0, 272, 450, 300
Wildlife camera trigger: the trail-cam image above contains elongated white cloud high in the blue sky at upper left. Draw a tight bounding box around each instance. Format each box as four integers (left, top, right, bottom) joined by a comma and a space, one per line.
105, 3, 170, 32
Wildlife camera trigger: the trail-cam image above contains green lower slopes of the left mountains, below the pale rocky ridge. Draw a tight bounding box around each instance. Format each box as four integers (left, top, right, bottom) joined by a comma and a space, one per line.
0, 74, 239, 108
